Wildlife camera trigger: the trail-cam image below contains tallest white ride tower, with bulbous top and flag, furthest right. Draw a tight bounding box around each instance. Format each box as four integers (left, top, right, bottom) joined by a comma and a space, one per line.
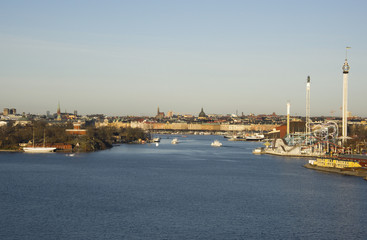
342, 47, 350, 144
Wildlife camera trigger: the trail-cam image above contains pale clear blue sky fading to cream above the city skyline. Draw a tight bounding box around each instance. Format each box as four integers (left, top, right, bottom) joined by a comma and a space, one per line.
0, 0, 367, 117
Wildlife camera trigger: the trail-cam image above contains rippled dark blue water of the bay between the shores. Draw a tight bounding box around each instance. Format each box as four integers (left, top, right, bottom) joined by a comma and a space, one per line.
0, 136, 367, 239
